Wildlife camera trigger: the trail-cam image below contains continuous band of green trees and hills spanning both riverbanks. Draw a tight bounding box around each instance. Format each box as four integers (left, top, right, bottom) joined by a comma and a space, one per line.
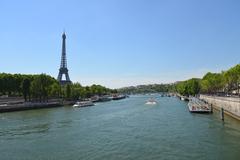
0, 64, 240, 101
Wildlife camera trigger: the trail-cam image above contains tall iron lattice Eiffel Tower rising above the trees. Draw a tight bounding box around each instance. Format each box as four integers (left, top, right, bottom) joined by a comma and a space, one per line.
57, 32, 72, 85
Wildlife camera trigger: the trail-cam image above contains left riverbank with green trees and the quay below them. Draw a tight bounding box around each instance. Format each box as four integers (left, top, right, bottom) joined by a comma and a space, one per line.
0, 73, 117, 113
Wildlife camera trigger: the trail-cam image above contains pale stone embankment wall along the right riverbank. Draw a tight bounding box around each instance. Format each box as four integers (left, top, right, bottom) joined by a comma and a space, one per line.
200, 95, 240, 120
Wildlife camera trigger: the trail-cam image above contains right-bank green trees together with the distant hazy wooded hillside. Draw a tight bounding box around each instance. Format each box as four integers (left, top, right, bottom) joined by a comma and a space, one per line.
118, 64, 240, 96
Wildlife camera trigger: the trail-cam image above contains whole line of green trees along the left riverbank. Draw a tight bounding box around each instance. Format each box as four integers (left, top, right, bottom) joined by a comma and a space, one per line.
0, 73, 116, 102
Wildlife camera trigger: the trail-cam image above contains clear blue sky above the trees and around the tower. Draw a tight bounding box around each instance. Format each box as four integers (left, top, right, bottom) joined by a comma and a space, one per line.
0, 0, 240, 88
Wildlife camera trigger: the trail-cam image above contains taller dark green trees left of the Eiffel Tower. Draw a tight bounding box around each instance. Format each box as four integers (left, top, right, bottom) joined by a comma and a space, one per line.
0, 73, 59, 101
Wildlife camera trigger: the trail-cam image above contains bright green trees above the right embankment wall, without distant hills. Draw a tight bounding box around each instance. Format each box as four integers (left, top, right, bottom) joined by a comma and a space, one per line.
175, 64, 240, 95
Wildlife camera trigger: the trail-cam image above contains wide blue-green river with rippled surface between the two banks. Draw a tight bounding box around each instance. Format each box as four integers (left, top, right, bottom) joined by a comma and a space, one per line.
0, 96, 240, 160
